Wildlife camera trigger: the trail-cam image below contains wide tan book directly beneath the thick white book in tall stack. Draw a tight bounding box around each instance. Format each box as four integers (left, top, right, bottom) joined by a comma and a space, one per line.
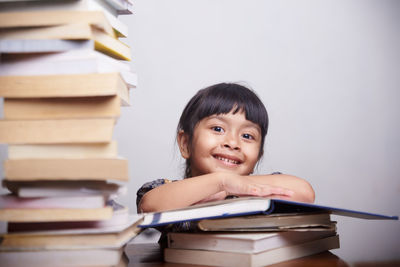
0, 72, 129, 104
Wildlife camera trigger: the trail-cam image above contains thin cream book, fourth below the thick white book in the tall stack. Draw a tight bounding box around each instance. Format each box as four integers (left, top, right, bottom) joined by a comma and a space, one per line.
7, 142, 118, 159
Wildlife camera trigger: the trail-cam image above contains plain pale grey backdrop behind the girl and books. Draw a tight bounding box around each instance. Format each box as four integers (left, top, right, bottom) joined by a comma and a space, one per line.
1, 0, 400, 262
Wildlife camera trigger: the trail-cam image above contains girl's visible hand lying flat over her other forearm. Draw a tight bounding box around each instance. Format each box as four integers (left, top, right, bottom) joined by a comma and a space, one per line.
222, 173, 294, 198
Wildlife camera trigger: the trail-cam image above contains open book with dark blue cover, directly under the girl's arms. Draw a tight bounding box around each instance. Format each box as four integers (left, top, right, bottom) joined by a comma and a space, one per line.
141, 197, 398, 227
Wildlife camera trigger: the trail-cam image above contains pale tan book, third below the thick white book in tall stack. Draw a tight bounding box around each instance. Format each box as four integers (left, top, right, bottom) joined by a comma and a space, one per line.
0, 118, 115, 144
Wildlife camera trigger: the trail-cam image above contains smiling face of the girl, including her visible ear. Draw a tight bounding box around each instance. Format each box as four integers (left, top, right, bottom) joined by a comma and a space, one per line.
179, 112, 261, 176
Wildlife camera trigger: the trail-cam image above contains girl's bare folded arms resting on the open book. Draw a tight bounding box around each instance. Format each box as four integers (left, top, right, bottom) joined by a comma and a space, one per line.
139, 172, 314, 215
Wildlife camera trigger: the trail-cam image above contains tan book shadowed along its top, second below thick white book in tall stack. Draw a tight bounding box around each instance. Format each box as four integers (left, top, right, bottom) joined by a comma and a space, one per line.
3, 96, 121, 120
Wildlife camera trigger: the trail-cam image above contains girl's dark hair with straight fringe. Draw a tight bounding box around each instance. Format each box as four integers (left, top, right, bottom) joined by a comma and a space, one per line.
177, 83, 268, 178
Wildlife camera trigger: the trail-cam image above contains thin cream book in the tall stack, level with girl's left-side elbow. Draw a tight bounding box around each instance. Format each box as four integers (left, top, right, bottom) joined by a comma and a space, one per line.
0, 206, 113, 222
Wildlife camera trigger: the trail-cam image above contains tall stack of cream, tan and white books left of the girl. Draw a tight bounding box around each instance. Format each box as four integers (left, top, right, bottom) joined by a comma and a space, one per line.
0, 0, 140, 266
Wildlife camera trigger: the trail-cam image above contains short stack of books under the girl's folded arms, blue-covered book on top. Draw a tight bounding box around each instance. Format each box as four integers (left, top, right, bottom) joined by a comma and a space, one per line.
139, 197, 398, 266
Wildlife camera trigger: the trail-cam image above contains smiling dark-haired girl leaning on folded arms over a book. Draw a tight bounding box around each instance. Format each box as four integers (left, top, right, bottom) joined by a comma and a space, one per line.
137, 83, 314, 216
